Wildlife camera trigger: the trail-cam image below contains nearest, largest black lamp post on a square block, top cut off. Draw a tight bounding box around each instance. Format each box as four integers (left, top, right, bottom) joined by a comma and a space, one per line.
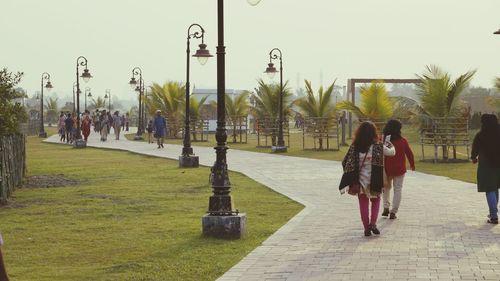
202, 0, 260, 238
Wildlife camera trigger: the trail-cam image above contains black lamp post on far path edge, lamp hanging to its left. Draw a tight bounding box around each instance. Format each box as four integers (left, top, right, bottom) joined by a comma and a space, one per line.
264, 48, 287, 152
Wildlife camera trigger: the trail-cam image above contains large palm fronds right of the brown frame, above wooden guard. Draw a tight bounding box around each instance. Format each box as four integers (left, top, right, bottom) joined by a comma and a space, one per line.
417, 65, 476, 117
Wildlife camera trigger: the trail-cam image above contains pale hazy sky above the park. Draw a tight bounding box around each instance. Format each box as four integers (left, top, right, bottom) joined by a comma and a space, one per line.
0, 0, 500, 102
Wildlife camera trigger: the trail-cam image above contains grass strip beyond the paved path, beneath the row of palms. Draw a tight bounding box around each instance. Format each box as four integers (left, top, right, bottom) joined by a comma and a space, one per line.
127, 126, 477, 183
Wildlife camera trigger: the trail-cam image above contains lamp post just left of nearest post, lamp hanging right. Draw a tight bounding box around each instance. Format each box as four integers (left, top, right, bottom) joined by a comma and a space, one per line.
179, 23, 212, 168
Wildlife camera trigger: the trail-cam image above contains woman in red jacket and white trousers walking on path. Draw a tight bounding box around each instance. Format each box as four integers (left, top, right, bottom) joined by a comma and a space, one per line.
382, 119, 415, 219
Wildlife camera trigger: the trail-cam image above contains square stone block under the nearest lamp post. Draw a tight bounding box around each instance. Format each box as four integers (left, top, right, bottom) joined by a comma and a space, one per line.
202, 213, 247, 239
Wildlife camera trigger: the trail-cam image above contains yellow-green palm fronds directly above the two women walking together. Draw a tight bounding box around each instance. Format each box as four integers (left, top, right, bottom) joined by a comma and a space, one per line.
337, 81, 394, 121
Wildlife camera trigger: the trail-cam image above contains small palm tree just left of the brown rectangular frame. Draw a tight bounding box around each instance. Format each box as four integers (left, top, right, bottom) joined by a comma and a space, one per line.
295, 80, 335, 150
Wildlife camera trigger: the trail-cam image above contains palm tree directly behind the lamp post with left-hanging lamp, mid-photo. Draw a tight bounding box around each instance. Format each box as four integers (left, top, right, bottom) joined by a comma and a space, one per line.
251, 79, 293, 146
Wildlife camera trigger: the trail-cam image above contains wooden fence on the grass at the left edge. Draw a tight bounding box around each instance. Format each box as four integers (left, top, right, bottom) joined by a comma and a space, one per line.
0, 134, 26, 203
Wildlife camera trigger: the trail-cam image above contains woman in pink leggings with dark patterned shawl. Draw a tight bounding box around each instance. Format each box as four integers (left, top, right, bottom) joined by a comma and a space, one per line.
339, 122, 396, 236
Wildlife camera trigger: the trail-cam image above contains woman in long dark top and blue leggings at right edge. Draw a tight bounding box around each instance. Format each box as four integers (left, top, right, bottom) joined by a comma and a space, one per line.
471, 114, 500, 224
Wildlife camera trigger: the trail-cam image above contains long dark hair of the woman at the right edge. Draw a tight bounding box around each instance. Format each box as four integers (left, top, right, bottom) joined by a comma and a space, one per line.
474, 114, 500, 167
